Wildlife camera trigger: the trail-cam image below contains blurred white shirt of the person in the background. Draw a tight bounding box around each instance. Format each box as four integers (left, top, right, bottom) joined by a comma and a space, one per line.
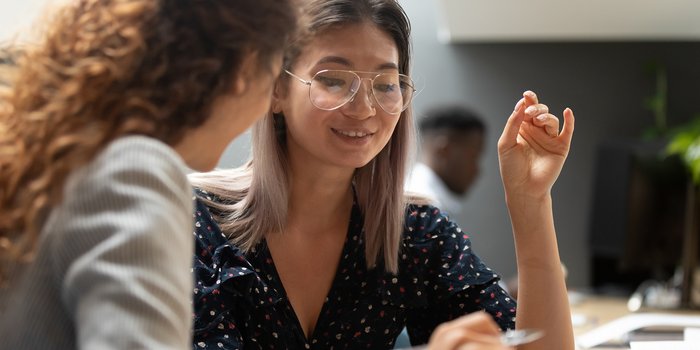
405, 162, 463, 216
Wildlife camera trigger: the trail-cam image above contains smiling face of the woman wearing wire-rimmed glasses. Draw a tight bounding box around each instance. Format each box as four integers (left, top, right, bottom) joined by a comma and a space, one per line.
282, 23, 403, 176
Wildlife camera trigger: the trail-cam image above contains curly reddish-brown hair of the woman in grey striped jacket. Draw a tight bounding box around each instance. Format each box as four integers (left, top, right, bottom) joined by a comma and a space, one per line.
0, 0, 297, 280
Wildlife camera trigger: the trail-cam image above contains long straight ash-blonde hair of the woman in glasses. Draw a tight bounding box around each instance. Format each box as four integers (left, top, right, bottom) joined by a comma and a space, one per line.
190, 0, 414, 273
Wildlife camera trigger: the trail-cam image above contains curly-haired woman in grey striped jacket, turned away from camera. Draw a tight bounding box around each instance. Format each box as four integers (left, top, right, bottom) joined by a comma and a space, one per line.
0, 0, 296, 349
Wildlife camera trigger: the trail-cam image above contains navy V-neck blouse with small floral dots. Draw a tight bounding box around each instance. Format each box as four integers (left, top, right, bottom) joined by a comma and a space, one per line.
193, 191, 515, 350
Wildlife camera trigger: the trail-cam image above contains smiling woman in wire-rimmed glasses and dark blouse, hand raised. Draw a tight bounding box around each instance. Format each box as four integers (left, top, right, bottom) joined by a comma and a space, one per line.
191, 0, 574, 349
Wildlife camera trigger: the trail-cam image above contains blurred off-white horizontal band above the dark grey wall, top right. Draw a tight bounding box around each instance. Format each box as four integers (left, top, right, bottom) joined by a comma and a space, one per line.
432, 0, 700, 43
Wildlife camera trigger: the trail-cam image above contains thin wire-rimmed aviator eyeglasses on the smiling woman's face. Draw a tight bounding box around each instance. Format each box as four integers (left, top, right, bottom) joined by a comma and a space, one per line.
285, 69, 416, 114
